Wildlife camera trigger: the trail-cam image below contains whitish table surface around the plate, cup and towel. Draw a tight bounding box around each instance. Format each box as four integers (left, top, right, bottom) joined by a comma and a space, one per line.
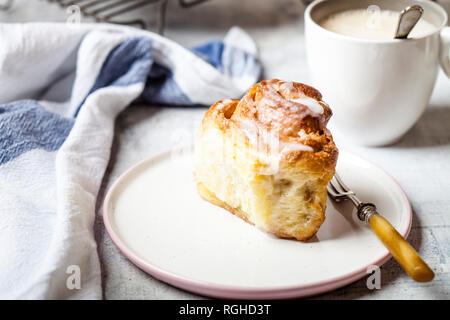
0, 0, 450, 299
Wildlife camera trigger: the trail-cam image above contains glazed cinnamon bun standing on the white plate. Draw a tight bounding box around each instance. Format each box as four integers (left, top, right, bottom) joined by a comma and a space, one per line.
195, 79, 338, 241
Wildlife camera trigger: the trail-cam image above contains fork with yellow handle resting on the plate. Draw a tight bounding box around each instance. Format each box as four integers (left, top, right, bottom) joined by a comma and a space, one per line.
327, 173, 434, 282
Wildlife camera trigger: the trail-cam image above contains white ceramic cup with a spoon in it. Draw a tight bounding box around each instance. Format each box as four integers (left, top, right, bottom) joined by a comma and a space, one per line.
305, 0, 450, 146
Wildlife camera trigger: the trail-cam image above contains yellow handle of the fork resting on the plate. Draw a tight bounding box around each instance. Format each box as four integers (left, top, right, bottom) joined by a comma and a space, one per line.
369, 214, 434, 282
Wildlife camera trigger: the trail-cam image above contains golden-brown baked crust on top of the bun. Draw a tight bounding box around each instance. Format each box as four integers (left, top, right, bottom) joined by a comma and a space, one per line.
202, 79, 338, 170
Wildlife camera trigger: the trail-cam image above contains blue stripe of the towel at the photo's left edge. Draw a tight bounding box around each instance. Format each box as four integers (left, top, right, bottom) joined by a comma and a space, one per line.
0, 100, 74, 165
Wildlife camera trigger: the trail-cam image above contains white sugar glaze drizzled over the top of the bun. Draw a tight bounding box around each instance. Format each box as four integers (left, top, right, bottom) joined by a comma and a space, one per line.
235, 80, 328, 156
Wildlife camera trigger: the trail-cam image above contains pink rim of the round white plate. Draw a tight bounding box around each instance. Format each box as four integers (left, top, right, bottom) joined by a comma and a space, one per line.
103, 150, 412, 299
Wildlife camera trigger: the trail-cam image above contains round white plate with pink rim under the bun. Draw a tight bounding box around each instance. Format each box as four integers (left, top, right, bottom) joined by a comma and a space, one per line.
103, 151, 412, 299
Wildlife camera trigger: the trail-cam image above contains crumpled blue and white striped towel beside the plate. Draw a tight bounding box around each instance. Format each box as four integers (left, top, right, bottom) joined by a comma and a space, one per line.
0, 23, 261, 299
